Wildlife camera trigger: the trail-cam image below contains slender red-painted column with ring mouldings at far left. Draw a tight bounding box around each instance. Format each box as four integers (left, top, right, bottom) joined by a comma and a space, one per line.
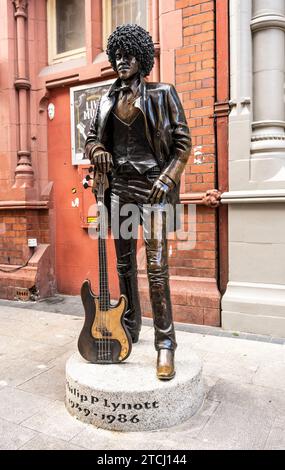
13, 0, 34, 188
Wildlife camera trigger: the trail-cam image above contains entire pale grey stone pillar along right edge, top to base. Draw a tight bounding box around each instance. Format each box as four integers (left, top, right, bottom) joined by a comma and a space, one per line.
222, 0, 285, 337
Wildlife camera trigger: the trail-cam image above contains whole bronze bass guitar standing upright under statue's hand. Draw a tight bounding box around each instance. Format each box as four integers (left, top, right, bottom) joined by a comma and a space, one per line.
78, 169, 132, 364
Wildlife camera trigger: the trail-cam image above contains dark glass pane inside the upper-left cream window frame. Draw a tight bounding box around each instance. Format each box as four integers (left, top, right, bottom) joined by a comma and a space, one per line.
56, 0, 85, 54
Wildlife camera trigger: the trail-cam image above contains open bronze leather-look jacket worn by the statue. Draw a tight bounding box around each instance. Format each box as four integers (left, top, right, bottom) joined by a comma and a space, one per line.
85, 77, 191, 229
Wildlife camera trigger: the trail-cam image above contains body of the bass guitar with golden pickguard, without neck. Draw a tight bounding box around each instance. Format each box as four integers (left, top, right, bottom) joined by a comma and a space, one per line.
78, 280, 132, 364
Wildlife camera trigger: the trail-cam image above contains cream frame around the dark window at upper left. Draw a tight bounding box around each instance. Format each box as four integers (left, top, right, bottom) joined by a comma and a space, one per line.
47, 0, 86, 65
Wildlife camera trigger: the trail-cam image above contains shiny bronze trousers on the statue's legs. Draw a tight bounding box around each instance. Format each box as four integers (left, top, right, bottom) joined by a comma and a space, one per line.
111, 165, 177, 350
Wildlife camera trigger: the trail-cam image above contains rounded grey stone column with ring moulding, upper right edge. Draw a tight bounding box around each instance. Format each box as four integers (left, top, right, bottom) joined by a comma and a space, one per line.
251, 0, 285, 182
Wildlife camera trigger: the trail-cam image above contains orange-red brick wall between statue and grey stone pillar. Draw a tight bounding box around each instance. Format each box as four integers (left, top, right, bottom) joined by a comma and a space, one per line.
170, 0, 217, 277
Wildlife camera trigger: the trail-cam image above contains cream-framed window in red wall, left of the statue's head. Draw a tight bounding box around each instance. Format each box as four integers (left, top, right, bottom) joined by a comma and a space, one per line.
48, 0, 85, 63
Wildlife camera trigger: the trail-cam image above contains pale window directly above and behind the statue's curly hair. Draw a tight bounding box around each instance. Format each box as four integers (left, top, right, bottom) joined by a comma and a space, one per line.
104, 0, 148, 43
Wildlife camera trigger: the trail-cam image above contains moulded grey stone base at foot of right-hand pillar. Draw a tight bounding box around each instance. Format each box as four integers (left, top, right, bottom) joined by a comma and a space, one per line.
222, 282, 285, 338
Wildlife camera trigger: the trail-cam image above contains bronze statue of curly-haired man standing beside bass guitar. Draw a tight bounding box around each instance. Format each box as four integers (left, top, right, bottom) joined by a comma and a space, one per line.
85, 24, 191, 380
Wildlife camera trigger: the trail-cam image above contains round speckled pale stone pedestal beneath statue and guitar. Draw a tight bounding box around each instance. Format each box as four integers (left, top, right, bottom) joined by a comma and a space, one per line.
66, 338, 203, 432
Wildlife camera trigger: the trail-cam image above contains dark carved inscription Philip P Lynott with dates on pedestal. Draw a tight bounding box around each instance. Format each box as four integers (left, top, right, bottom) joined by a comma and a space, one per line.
67, 382, 159, 424
